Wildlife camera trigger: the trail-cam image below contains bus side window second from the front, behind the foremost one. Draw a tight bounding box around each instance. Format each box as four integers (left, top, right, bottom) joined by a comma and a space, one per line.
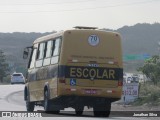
36, 43, 45, 67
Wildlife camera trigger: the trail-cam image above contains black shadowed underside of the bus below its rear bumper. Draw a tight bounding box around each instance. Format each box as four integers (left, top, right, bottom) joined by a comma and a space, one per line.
51, 95, 120, 108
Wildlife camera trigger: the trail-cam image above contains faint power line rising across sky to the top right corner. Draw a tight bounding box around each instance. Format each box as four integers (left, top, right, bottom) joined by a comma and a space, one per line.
0, 0, 159, 13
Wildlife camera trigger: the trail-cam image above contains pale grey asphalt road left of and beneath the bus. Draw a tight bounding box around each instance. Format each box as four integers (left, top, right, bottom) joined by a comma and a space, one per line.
0, 85, 149, 120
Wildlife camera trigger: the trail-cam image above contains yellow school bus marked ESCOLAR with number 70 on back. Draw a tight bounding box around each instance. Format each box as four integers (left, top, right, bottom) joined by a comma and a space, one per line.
23, 26, 123, 116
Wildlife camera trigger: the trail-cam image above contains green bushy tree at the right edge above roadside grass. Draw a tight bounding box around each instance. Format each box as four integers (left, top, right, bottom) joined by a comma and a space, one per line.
139, 55, 160, 85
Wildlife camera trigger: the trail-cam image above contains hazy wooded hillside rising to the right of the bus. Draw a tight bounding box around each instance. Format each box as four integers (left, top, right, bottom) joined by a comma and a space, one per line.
117, 23, 160, 55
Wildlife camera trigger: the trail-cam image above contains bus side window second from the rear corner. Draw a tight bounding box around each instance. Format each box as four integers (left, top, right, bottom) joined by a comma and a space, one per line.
43, 40, 53, 66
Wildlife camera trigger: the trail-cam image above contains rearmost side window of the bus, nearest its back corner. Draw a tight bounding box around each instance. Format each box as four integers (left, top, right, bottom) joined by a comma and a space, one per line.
51, 38, 61, 64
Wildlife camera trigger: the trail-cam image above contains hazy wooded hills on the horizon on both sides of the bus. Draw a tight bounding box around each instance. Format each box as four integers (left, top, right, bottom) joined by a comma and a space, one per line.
0, 23, 160, 71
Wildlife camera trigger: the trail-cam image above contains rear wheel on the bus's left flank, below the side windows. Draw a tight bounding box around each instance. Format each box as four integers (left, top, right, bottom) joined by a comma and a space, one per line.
44, 90, 50, 112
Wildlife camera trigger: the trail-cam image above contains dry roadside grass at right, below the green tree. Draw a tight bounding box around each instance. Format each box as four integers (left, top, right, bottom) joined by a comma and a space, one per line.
132, 82, 160, 106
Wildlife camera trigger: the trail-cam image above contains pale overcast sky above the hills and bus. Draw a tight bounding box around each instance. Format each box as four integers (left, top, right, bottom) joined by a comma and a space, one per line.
0, 0, 160, 32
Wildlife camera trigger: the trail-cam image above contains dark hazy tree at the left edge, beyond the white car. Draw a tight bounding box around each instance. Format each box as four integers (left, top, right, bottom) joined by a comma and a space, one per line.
0, 50, 9, 82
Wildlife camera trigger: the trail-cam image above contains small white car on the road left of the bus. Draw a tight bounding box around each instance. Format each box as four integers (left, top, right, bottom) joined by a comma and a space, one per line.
11, 73, 25, 84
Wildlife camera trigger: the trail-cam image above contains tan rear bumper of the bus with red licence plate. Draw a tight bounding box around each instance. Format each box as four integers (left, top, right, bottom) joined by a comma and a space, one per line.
58, 86, 122, 101
